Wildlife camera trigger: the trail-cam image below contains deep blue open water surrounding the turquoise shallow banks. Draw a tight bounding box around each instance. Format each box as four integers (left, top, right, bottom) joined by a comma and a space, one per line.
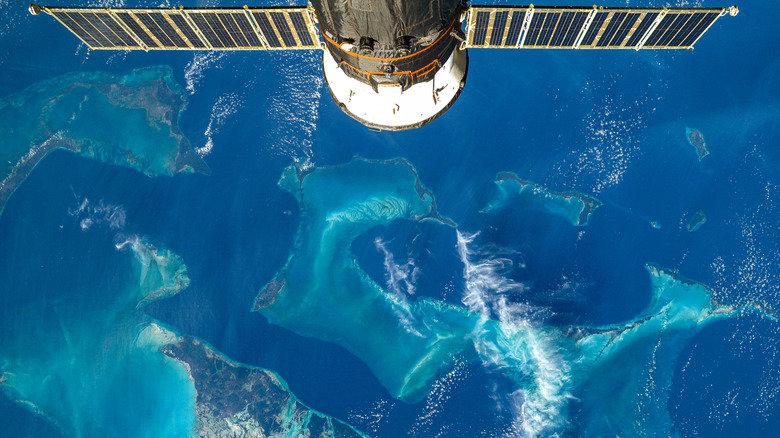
0, 1, 780, 436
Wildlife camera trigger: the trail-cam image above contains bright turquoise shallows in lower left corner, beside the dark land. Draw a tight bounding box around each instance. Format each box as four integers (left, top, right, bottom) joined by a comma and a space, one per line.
0, 238, 195, 437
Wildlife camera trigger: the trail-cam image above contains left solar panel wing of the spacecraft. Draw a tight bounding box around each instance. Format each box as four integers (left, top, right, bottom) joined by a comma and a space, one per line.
36, 5, 321, 50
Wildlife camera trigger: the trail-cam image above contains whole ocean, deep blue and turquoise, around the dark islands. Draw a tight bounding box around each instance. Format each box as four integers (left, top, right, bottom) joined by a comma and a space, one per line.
0, 0, 780, 437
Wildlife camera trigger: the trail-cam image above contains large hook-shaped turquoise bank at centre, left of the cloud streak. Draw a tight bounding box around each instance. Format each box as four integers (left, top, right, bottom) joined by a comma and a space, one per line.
253, 157, 476, 402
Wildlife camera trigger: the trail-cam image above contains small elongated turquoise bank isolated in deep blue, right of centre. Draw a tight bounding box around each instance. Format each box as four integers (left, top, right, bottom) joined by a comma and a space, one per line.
482, 172, 602, 226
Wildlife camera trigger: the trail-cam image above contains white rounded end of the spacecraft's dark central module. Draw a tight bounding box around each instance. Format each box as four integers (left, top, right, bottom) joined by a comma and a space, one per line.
322, 49, 468, 131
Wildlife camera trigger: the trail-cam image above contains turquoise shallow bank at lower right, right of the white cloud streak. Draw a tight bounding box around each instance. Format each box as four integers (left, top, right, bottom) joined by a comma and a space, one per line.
570, 263, 764, 436
